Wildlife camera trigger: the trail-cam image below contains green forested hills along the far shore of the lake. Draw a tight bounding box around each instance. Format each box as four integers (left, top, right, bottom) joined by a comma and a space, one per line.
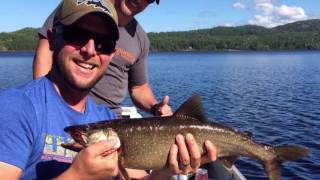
0, 19, 320, 51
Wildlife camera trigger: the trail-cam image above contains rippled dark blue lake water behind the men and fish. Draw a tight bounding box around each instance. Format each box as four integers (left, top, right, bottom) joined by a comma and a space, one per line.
0, 51, 320, 179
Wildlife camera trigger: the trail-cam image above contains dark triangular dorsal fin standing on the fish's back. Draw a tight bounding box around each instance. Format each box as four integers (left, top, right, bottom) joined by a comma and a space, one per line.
173, 94, 208, 122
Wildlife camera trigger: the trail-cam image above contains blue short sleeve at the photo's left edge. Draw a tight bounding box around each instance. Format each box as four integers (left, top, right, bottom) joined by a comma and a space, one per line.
0, 93, 36, 169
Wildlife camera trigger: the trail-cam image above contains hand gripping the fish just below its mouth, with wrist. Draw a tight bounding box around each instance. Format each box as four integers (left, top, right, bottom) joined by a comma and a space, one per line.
57, 140, 119, 179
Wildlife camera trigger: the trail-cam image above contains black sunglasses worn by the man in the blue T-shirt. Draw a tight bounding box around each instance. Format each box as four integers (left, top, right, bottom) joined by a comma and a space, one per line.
58, 26, 116, 54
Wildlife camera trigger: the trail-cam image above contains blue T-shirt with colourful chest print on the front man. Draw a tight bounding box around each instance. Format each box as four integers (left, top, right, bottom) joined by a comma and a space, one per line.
0, 76, 116, 179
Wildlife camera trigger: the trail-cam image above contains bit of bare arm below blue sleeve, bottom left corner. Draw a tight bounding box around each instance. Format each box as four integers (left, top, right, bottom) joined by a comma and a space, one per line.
0, 162, 22, 180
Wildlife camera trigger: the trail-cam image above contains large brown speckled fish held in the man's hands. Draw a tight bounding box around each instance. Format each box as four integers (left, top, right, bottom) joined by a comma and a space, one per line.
64, 94, 310, 180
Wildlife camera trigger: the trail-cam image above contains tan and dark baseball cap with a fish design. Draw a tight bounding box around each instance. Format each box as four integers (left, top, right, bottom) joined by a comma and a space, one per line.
53, 0, 119, 40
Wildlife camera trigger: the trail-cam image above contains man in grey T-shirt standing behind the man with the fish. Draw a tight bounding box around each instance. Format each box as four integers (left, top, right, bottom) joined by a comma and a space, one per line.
33, 0, 172, 116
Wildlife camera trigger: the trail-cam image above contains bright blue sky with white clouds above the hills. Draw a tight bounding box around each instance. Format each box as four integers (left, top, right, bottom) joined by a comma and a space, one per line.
0, 0, 320, 32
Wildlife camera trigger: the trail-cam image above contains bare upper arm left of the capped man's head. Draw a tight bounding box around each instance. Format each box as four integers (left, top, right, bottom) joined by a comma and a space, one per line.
33, 35, 52, 79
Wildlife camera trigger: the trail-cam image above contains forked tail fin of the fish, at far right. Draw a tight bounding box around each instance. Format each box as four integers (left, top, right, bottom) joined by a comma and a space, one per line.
262, 145, 310, 180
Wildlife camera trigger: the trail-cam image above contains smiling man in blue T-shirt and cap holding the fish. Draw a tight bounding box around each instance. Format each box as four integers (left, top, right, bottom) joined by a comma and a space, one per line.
0, 0, 216, 179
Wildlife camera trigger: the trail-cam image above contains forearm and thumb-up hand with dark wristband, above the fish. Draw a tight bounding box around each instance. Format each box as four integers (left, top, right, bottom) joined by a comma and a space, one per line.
130, 83, 172, 116
